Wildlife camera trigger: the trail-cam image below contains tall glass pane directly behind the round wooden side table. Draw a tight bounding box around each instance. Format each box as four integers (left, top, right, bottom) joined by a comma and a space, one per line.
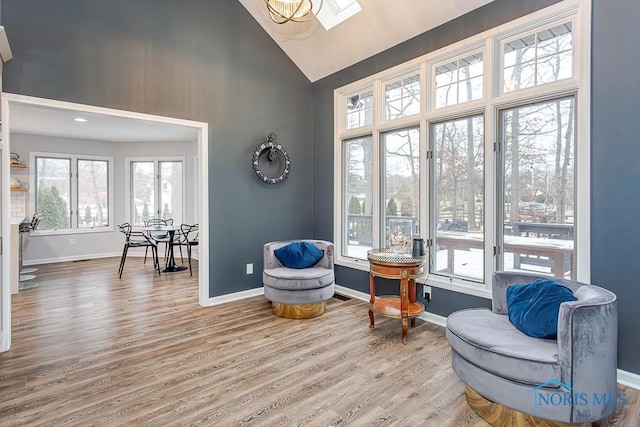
382, 128, 420, 251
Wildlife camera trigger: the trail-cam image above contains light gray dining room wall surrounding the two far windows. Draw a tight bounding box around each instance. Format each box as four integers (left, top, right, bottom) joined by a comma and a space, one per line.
11, 132, 198, 264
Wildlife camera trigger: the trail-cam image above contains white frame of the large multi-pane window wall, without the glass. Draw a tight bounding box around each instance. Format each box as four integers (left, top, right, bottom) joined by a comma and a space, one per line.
334, 0, 591, 298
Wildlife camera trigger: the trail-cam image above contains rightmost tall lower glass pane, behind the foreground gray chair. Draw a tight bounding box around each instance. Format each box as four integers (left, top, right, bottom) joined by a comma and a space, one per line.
500, 97, 575, 278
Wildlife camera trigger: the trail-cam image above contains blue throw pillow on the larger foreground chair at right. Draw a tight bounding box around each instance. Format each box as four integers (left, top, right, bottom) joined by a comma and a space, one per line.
507, 279, 578, 339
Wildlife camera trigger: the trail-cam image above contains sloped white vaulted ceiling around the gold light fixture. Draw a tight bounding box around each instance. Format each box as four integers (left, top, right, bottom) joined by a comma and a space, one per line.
239, 0, 493, 82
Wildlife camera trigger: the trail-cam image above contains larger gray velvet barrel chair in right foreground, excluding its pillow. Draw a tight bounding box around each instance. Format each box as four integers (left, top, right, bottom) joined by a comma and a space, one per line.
446, 272, 618, 426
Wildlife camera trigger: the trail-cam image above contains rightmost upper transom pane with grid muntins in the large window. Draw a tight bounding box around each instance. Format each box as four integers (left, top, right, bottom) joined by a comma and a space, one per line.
502, 22, 573, 93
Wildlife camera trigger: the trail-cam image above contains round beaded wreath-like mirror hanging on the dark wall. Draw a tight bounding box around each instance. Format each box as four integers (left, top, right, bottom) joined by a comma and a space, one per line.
252, 132, 291, 184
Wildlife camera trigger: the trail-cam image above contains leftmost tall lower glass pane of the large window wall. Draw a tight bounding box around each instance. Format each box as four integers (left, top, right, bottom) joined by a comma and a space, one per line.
342, 136, 373, 260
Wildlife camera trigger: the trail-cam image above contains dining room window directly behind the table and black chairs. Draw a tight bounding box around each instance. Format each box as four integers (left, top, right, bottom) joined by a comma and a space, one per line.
129, 160, 184, 225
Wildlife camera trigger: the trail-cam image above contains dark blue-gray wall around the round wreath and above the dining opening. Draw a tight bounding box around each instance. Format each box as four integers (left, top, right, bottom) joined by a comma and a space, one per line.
2, 0, 313, 296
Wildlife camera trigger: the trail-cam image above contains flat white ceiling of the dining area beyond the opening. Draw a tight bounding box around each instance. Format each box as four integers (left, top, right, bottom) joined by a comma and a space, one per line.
9, 103, 198, 142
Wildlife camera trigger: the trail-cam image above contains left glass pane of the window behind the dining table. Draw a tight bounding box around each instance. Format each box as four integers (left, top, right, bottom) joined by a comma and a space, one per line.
131, 162, 156, 225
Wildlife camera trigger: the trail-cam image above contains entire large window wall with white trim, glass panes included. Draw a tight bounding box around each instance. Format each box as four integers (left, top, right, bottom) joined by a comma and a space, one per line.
334, 0, 590, 296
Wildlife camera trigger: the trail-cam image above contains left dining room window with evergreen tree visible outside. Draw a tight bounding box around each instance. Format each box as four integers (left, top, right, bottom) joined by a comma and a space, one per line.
33, 153, 112, 231
